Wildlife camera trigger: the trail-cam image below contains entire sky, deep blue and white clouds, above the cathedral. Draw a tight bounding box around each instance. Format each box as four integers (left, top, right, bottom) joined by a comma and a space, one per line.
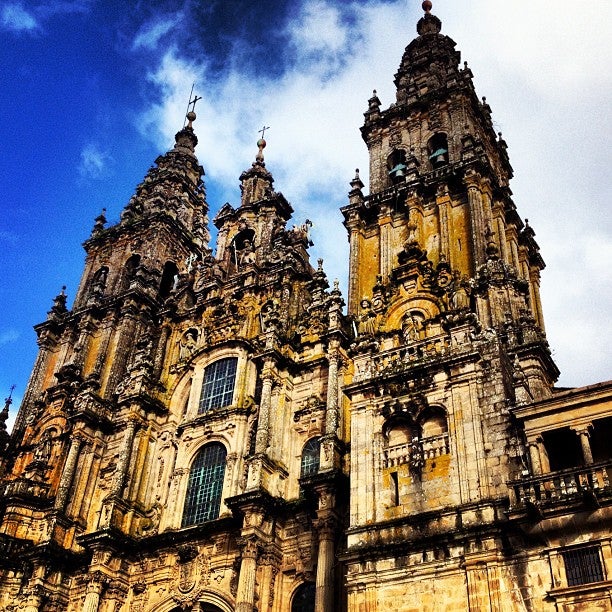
0, 0, 612, 430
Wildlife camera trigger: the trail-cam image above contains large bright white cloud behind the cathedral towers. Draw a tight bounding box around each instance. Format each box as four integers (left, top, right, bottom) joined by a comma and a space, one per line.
136, 0, 612, 384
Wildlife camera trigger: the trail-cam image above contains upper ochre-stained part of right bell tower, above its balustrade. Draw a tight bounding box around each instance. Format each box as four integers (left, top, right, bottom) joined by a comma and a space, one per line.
342, 2, 557, 395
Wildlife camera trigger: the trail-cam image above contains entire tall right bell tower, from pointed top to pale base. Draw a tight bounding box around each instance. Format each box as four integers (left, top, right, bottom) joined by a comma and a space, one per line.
342, 1, 558, 609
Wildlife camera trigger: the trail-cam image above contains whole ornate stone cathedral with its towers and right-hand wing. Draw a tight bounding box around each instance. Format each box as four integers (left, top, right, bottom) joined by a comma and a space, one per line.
0, 1, 612, 612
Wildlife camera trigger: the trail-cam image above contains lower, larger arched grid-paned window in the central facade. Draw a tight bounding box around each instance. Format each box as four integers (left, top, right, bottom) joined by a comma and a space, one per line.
183, 442, 227, 527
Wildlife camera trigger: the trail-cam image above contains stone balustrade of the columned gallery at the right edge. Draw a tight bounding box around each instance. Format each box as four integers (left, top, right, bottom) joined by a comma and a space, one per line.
508, 461, 612, 514
